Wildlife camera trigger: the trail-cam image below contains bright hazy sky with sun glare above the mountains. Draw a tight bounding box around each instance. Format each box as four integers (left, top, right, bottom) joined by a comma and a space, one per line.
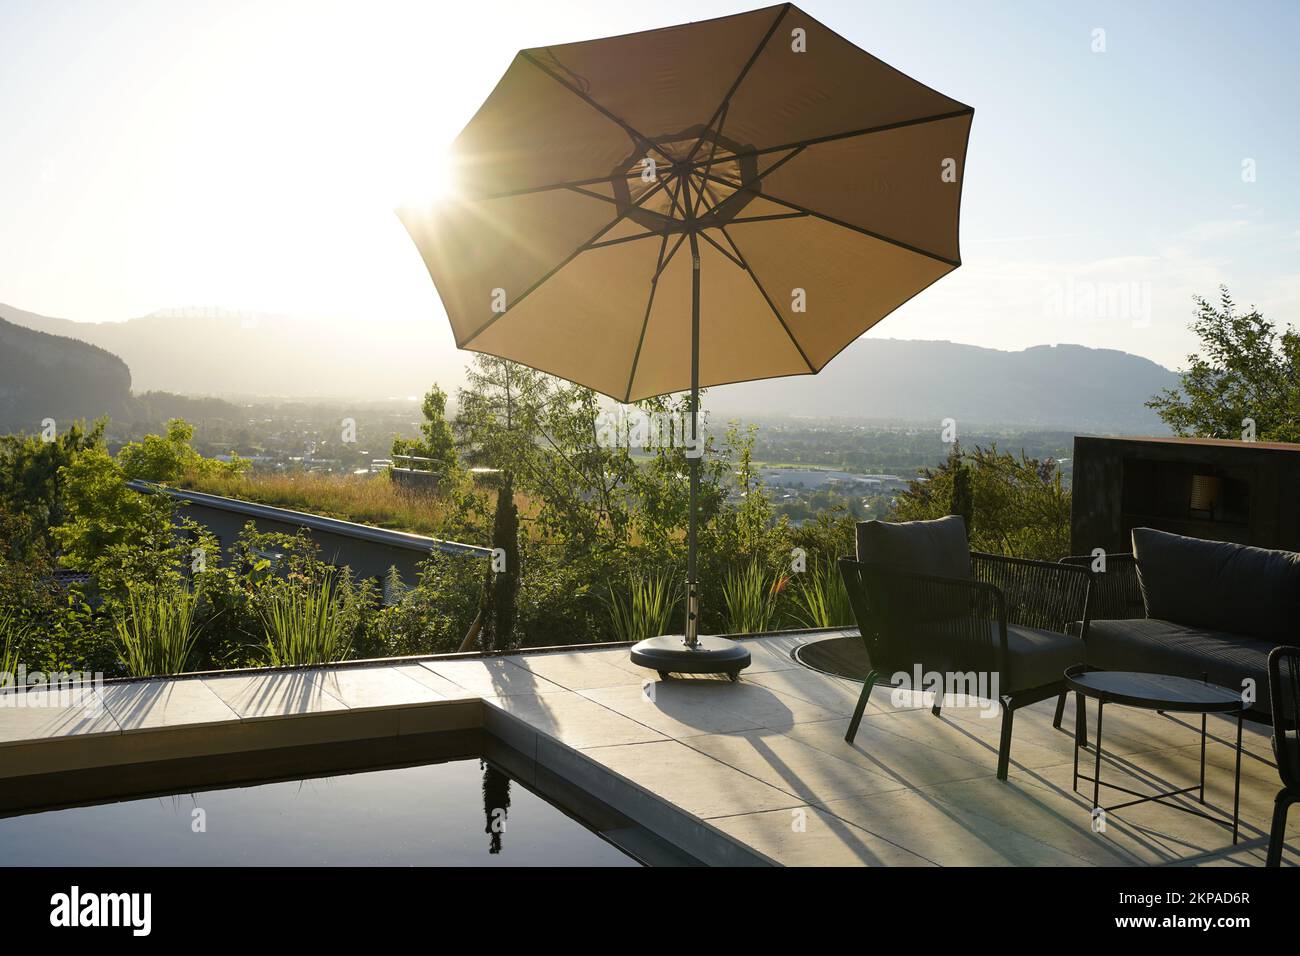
0, 0, 1300, 365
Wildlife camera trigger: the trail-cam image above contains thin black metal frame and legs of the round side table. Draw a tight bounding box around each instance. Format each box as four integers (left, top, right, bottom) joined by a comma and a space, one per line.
1065, 665, 1245, 845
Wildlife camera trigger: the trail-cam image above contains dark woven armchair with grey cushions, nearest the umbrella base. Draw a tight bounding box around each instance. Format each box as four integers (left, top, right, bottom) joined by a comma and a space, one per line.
840, 516, 1091, 780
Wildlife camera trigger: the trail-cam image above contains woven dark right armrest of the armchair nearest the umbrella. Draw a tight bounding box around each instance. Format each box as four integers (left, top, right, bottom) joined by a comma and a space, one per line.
971, 551, 1092, 637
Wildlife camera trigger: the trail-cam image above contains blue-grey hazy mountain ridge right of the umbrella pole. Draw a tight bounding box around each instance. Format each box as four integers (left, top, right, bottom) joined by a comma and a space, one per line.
707, 338, 1179, 434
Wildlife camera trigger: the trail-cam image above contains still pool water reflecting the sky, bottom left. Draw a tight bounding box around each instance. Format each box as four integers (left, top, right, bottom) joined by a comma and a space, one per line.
0, 758, 640, 866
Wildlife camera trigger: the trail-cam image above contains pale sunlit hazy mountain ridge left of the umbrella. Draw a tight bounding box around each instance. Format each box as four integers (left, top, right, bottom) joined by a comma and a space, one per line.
0, 304, 468, 399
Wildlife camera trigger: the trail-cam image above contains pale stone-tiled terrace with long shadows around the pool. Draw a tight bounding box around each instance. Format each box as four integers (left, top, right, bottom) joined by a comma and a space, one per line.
0, 632, 1300, 866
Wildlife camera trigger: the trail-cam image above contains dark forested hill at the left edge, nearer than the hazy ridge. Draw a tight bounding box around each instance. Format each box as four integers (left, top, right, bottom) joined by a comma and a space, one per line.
0, 313, 131, 432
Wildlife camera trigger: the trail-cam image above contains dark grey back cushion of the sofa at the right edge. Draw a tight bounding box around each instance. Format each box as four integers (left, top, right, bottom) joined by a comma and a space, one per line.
1134, 528, 1300, 644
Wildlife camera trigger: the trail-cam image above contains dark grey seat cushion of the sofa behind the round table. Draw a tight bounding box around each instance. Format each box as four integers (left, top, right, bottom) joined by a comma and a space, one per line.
1086, 618, 1275, 713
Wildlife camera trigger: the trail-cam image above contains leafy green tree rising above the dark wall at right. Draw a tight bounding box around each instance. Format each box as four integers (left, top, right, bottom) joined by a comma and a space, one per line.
1147, 286, 1300, 441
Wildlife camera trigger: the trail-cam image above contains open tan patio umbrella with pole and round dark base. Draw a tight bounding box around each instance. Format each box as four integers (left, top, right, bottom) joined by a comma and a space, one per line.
398, 4, 974, 679
